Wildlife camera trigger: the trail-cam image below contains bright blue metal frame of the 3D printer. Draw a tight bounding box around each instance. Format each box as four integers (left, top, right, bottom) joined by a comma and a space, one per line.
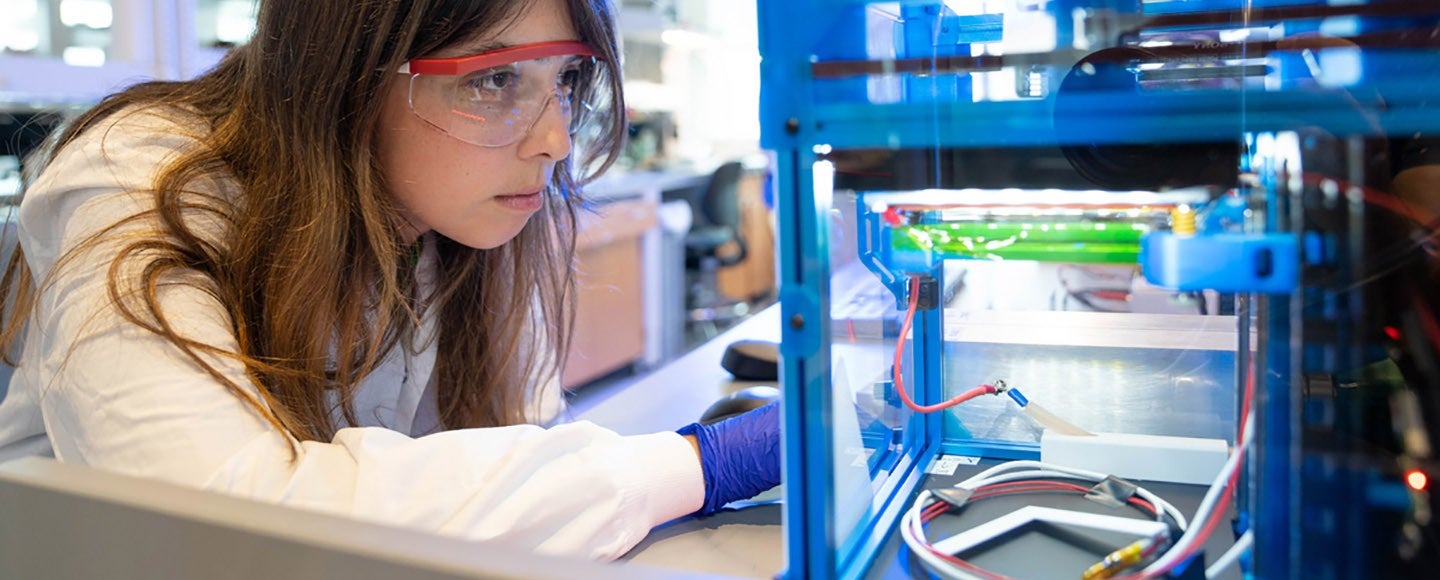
757, 0, 1440, 580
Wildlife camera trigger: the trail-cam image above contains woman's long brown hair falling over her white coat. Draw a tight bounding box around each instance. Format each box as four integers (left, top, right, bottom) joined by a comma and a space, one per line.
0, 0, 625, 440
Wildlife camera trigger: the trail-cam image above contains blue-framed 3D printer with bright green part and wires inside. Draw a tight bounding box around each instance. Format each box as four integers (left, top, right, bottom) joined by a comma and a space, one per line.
759, 0, 1440, 579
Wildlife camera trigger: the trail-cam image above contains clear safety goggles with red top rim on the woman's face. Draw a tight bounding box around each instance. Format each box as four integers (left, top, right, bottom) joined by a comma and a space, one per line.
399, 40, 611, 147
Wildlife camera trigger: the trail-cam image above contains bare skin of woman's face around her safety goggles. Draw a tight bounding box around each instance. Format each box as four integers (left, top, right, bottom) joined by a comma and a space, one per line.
377, 0, 579, 249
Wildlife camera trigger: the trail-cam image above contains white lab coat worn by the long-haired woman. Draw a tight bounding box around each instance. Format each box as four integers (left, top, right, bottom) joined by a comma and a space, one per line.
0, 106, 704, 558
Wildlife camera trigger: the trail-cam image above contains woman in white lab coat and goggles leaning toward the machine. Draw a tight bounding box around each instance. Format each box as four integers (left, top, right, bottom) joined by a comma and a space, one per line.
0, 0, 779, 558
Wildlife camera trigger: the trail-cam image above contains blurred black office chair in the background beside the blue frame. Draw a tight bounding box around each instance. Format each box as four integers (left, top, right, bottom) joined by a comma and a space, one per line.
685, 161, 750, 337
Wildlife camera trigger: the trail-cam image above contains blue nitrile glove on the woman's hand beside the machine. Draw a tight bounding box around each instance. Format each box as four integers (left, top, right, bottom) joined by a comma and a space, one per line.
678, 403, 780, 515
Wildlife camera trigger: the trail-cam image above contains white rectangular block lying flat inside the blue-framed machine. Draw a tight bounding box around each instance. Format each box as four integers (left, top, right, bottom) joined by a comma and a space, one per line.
1040, 429, 1230, 485
